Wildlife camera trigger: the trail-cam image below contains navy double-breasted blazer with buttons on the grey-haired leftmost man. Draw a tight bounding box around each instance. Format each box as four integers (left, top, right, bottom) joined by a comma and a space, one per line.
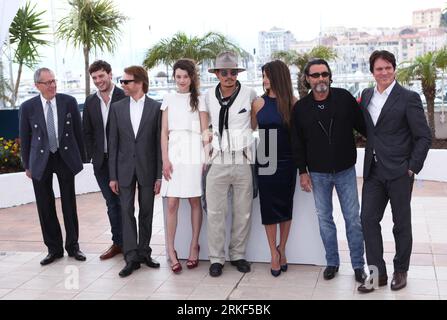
20, 93, 85, 180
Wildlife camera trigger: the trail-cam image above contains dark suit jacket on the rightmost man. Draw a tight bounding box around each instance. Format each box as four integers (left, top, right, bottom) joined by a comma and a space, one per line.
360, 82, 431, 180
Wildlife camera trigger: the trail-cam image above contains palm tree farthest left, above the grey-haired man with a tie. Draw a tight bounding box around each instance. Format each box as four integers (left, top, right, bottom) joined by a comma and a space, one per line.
9, 2, 49, 105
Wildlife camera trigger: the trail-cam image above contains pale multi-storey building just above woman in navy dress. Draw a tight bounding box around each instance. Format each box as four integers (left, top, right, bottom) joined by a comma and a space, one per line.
258, 27, 296, 64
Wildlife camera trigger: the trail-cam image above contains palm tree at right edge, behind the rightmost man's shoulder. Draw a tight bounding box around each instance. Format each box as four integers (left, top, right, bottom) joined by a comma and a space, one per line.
397, 48, 447, 138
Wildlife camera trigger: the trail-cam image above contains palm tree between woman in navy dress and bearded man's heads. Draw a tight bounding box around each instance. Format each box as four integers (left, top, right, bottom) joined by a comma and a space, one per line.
272, 46, 337, 99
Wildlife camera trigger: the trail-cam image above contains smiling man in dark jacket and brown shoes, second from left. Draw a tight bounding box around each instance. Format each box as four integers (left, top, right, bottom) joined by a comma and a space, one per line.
82, 60, 126, 260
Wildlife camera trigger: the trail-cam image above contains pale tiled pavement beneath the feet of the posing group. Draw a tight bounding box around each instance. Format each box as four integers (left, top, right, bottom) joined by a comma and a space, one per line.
0, 181, 447, 300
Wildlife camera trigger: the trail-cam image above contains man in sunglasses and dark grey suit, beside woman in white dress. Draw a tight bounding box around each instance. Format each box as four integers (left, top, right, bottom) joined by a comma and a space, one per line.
109, 66, 161, 277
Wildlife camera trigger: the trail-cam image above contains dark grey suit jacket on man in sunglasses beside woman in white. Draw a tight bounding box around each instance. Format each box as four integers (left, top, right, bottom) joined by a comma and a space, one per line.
109, 96, 162, 187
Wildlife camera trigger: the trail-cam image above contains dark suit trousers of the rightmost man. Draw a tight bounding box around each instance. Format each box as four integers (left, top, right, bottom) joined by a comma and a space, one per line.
361, 163, 414, 275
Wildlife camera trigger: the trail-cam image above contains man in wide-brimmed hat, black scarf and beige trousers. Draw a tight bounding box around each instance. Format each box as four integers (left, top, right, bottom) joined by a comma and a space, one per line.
200, 51, 256, 277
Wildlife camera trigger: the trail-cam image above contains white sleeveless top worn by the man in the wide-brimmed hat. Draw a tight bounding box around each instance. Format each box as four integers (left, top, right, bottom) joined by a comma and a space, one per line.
207, 85, 254, 151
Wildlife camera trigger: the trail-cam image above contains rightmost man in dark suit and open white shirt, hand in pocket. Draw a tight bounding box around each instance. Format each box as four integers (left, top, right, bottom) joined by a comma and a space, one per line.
358, 50, 431, 293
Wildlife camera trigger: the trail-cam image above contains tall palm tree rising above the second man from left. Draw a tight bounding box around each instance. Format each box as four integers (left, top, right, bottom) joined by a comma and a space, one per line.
56, 0, 127, 95
